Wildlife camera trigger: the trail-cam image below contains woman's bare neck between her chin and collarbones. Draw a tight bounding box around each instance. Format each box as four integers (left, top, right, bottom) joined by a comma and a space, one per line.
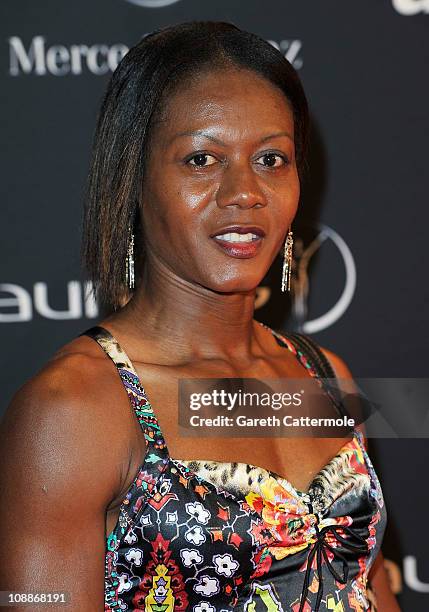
105, 260, 266, 362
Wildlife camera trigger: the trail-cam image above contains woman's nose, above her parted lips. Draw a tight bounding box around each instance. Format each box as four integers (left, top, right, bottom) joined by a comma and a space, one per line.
216, 163, 266, 208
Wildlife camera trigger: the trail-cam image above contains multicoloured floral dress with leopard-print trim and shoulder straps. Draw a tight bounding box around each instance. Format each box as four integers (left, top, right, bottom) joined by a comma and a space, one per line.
79, 326, 386, 612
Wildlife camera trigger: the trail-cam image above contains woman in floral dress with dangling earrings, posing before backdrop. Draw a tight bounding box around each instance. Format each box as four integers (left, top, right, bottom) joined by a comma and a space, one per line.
1, 22, 399, 612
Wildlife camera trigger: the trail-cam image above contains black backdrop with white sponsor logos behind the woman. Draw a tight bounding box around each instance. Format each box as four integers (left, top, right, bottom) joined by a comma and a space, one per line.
0, 0, 429, 612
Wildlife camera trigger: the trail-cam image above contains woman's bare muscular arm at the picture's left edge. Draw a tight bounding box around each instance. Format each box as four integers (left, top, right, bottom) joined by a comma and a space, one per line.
0, 355, 128, 612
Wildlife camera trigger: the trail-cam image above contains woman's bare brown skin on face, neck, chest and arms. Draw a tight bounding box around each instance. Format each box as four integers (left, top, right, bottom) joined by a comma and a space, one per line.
0, 69, 399, 612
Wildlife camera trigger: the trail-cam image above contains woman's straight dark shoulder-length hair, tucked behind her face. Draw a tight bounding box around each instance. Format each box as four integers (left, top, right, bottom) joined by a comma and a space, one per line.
82, 21, 308, 310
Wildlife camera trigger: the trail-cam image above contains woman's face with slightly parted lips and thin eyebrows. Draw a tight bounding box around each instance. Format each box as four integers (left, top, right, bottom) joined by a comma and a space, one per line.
142, 69, 300, 293
